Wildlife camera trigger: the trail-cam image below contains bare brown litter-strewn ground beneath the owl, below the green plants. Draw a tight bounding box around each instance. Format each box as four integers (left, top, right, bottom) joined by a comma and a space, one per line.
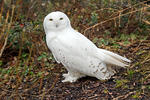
0, 37, 150, 100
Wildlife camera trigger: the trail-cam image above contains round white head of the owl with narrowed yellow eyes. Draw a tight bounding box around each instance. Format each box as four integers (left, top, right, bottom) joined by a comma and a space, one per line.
43, 11, 71, 33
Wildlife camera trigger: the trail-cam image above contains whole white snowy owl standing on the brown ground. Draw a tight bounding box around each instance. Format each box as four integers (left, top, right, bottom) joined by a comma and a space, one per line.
43, 11, 130, 82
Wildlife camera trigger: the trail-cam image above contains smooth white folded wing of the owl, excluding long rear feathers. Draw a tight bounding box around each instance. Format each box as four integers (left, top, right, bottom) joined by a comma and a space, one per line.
61, 30, 98, 58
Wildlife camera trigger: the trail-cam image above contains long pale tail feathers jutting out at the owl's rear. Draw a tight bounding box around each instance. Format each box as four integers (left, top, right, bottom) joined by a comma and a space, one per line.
98, 49, 131, 67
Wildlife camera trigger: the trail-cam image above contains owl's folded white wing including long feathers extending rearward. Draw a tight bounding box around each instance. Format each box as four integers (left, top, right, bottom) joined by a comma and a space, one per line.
58, 30, 131, 67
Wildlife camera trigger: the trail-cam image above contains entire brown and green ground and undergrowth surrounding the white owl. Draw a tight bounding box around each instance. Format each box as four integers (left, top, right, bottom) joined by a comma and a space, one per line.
0, 0, 150, 100
